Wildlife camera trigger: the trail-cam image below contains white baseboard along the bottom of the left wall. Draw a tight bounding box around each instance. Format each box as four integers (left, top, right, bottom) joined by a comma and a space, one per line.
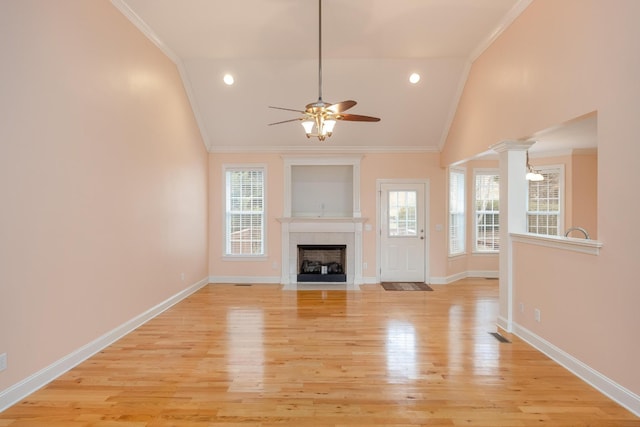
0, 278, 209, 412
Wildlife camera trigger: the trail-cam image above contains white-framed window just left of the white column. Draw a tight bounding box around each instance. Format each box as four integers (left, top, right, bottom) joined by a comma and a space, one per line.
473, 170, 500, 252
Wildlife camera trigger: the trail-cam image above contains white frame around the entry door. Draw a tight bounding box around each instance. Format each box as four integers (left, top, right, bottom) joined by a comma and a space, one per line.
376, 178, 431, 283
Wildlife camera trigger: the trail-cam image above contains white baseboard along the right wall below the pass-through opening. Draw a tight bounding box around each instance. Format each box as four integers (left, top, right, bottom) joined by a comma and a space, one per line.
513, 323, 640, 417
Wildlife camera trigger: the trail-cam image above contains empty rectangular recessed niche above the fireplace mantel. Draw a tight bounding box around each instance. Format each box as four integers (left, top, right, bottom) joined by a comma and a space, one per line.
291, 165, 353, 218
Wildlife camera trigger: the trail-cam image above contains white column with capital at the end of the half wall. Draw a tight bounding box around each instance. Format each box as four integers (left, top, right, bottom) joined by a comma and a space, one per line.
491, 141, 535, 332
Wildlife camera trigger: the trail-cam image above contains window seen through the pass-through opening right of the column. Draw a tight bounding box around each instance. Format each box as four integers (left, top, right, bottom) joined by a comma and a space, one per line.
527, 166, 564, 236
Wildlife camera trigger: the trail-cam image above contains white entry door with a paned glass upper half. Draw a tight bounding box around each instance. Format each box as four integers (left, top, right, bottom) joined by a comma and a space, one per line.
379, 183, 426, 283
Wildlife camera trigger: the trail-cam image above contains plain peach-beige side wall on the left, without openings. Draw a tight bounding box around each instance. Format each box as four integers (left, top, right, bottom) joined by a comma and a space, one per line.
0, 0, 207, 394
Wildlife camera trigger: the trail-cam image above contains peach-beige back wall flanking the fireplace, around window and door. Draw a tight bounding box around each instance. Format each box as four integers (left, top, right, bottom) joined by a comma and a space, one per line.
209, 153, 447, 280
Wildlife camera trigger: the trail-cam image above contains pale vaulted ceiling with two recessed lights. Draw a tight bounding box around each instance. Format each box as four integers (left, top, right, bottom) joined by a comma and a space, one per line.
112, 0, 531, 152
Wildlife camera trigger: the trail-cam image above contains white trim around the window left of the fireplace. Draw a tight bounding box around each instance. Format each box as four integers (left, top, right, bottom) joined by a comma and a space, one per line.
221, 163, 269, 261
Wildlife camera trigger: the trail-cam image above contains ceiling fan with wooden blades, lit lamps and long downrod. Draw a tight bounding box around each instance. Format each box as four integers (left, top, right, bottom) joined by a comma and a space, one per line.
269, 0, 380, 141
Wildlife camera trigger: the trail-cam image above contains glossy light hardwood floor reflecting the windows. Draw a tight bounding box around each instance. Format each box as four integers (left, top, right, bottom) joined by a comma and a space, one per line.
0, 279, 640, 427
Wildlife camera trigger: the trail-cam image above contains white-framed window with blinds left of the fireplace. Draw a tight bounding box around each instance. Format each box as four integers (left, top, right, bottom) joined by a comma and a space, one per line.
225, 167, 265, 256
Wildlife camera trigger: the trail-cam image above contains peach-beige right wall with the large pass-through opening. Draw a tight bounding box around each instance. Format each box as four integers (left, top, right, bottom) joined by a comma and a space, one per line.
442, 0, 640, 395
